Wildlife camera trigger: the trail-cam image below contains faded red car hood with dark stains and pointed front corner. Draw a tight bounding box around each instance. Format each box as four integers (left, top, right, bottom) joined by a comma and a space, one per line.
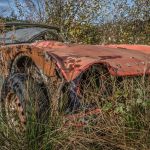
32, 41, 150, 81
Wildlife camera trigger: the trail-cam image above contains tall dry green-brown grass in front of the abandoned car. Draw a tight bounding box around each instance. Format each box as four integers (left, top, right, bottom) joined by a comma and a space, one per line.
0, 66, 150, 150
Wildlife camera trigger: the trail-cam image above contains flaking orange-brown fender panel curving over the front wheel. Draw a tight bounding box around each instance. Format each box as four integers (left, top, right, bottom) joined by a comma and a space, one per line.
0, 45, 56, 77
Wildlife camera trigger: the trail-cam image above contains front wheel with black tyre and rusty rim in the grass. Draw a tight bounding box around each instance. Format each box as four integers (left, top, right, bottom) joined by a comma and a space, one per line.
1, 73, 50, 132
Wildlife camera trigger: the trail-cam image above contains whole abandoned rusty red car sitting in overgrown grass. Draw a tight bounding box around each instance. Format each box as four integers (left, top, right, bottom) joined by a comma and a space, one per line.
0, 23, 150, 129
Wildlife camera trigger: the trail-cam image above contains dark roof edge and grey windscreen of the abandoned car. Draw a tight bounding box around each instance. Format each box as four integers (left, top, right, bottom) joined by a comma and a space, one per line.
0, 22, 60, 44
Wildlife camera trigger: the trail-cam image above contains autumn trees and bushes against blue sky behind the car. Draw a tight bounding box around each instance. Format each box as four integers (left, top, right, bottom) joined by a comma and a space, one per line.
0, 0, 150, 44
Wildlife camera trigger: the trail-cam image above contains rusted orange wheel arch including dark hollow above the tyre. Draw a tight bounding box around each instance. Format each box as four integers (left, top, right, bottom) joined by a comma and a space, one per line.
1, 45, 65, 79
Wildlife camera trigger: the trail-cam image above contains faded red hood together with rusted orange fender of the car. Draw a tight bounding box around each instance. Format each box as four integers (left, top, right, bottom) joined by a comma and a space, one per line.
1, 41, 150, 81
